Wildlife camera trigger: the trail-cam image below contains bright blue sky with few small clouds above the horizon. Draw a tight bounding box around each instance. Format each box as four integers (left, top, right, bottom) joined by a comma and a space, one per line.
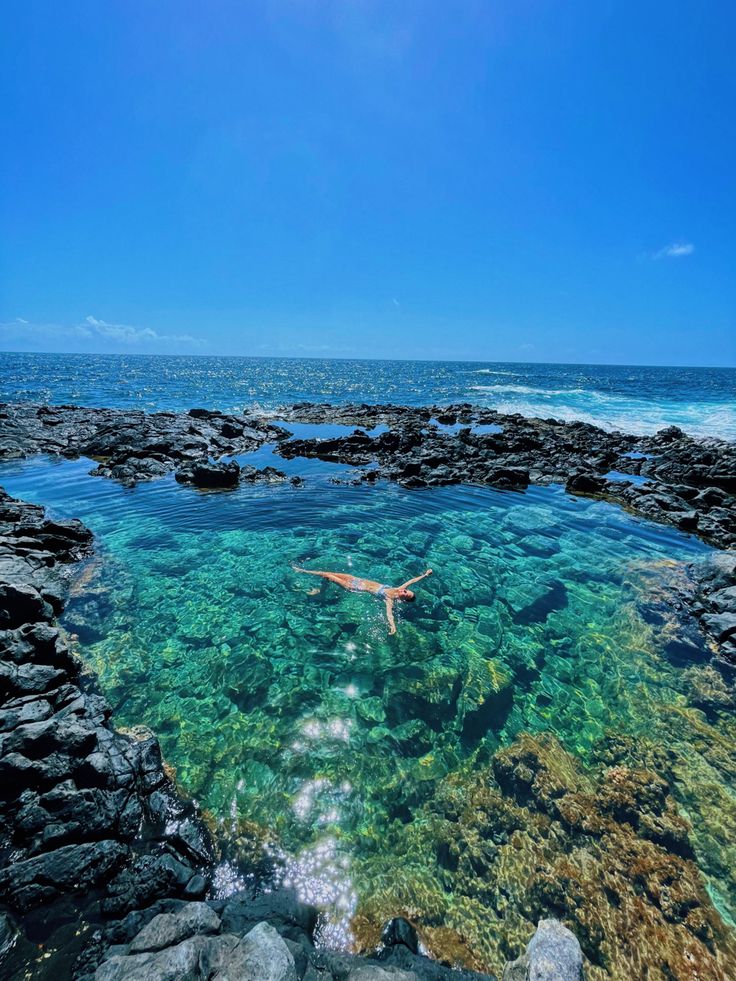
0, 0, 736, 365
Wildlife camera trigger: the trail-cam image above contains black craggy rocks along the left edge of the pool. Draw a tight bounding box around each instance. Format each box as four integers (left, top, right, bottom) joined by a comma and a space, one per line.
0, 491, 214, 976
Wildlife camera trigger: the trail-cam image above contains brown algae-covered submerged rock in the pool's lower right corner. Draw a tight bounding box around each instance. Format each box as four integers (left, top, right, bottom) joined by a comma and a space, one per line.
355, 734, 736, 981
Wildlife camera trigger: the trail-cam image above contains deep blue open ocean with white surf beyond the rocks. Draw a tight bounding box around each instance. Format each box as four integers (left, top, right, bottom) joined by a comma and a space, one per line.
0, 354, 736, 439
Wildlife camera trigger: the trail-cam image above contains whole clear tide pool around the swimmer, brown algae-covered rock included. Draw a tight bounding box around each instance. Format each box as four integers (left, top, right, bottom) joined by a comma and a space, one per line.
3, 462, 736, 979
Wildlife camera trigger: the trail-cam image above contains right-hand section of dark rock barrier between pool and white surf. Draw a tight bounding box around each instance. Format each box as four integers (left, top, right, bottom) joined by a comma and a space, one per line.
277, 404, 736, 548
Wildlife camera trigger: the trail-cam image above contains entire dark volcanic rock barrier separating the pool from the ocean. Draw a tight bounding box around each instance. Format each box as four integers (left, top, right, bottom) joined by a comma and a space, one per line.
0, 403, 736, 548
